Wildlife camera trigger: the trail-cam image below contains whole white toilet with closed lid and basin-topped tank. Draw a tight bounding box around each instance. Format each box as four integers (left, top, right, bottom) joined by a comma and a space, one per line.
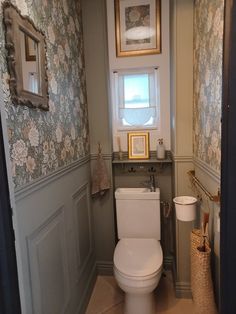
114, 188, 163, 314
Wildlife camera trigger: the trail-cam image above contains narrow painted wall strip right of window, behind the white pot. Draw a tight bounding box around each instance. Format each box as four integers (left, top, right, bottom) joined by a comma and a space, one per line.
170, 0, 194, 297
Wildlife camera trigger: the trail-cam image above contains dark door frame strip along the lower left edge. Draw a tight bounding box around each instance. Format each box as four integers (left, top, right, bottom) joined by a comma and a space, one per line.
0, 119, 21, 314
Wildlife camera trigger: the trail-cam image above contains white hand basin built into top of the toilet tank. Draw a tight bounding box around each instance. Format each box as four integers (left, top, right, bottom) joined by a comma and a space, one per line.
115, 188, 160, 200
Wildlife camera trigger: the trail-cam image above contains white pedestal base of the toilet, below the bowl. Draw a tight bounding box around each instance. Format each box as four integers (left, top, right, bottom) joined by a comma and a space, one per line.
124, 292, 155, 314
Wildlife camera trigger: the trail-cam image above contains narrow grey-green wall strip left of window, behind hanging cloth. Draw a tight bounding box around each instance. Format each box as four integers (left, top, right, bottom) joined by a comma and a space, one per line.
82, 0, 115, 273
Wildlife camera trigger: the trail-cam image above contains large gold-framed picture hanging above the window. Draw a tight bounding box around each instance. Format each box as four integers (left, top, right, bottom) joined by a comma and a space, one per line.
115, 0, 161, 57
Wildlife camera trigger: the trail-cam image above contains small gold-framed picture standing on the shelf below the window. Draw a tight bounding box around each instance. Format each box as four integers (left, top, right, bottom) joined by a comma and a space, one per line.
128, 132, 149, 159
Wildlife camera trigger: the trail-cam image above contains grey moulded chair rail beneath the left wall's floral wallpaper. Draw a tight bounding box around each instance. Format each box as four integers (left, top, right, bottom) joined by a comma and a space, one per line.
15, 155, 90, 201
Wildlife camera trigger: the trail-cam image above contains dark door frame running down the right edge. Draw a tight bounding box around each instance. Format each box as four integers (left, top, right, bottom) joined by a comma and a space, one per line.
220, 0, 236, 314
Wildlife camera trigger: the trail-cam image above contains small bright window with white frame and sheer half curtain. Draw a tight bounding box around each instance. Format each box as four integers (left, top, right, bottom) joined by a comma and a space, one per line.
114, 69, 159, 129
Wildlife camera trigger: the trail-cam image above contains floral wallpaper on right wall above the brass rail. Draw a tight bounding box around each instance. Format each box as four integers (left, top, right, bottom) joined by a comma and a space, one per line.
194, 0, 224, 172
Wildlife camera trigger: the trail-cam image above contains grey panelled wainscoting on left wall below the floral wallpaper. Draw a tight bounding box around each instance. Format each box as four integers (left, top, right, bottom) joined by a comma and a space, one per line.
14, 156, 96, 314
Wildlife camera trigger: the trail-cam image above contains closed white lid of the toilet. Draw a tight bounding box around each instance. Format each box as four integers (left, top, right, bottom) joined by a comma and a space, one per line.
114, 238, 163, 276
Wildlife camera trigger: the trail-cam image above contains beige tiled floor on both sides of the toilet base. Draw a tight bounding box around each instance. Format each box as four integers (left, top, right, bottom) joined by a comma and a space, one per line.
86, 272, 194, 314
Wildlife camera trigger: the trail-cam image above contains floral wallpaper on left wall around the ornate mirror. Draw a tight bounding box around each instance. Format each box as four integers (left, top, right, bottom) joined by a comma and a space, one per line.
0, 0, 89, 187
